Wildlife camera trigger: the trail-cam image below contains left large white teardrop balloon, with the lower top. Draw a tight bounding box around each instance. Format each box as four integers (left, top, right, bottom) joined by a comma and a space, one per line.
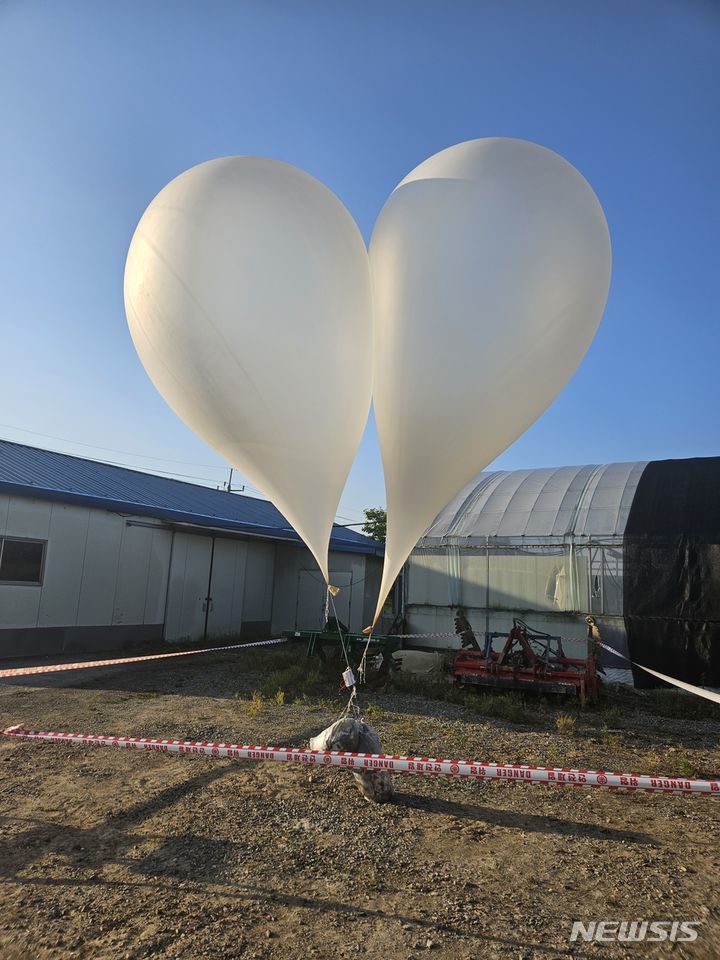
125, 157, 372, 580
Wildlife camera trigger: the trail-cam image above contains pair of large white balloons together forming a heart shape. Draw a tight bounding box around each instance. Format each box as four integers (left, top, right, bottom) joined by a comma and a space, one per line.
125, 138, 611, 622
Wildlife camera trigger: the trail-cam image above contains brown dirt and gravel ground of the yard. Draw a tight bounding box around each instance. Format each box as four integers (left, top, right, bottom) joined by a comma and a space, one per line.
0, 636, 720, 960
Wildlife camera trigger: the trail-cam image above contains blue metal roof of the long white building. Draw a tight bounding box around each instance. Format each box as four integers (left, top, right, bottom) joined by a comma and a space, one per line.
0, 440, 383, 556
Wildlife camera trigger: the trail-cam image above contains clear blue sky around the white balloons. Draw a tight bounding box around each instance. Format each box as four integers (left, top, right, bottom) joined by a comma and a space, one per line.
0, 0, 720, 520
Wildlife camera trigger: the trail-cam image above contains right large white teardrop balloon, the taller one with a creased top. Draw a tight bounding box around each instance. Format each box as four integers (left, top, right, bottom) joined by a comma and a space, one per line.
370, 138, 611, 620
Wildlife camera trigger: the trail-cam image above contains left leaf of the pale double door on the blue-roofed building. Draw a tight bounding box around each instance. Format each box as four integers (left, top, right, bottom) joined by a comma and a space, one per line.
165, 533, 212, 640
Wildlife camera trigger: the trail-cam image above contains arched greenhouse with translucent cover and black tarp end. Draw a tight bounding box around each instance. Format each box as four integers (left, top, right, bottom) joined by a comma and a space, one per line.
404, 458, 720, 685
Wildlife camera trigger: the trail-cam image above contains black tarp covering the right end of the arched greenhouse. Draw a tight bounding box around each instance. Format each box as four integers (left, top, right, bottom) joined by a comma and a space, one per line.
623, 457, 720, 687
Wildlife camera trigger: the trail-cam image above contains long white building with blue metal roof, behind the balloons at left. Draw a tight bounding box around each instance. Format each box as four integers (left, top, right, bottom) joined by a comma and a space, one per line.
0, 441, 383, 657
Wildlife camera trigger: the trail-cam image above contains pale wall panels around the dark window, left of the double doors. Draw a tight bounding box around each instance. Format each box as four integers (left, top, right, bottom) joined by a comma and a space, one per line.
0, 496, 171, 657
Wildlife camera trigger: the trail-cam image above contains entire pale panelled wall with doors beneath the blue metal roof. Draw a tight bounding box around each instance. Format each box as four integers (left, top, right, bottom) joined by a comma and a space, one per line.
0, 496, 381, 657
